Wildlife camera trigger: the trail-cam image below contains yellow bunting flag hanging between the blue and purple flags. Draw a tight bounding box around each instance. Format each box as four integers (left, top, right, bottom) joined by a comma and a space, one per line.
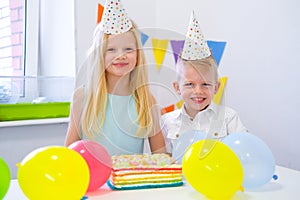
152, 38, 169, 70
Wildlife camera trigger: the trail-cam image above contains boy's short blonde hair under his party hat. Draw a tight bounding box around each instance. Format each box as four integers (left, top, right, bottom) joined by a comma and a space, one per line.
176, 55, 219, 83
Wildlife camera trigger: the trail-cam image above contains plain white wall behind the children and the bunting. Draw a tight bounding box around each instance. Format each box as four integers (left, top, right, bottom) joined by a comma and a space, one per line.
75, 0, 300, 170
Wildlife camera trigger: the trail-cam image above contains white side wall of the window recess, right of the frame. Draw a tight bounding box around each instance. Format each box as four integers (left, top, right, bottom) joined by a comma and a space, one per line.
38, 0, 76, 101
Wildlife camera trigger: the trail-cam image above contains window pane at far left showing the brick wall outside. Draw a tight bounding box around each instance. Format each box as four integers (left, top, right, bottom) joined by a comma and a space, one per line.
0, 0, 25, 103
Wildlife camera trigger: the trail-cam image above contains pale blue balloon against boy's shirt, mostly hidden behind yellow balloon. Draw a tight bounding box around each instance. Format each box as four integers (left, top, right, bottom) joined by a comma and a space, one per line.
172, 130, 206, 163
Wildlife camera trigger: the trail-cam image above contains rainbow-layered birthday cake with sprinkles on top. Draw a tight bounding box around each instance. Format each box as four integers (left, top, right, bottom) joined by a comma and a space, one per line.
107, 154, 183, 190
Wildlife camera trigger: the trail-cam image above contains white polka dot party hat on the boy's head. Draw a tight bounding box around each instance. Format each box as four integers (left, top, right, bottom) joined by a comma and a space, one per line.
181, 12, 211, 60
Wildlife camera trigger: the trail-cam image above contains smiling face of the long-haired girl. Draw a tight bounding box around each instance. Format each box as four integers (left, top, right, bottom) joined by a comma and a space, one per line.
104, 31, 137, 77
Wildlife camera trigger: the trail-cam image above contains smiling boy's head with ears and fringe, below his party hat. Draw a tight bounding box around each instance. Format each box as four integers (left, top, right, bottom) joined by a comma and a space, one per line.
173, 62, 219, 117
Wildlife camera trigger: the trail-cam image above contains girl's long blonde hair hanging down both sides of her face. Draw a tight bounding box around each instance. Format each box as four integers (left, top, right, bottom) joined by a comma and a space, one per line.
81, 22, 155, 137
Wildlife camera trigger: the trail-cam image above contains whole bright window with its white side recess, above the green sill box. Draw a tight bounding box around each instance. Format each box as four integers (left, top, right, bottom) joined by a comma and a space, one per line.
0, 0, 75, 121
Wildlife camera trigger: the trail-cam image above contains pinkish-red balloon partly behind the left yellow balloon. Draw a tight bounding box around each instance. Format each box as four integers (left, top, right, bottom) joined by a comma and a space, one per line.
69, 140, 112, 191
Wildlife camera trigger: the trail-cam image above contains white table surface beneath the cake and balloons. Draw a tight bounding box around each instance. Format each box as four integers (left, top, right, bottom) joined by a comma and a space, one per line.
4, 166, 300, 200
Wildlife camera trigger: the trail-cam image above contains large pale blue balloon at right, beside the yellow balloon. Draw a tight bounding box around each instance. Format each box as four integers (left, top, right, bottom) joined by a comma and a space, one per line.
222, 132, 275, 188
